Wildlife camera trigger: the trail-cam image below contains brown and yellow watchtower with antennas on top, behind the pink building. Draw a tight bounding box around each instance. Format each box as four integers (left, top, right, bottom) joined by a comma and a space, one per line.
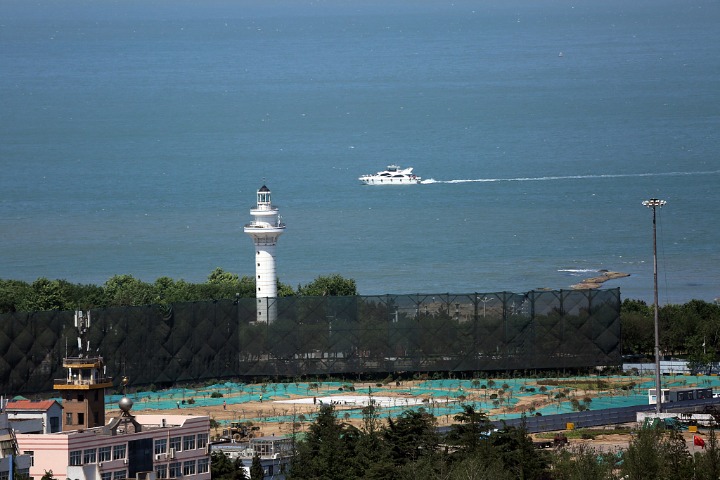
54, 311, 112, 431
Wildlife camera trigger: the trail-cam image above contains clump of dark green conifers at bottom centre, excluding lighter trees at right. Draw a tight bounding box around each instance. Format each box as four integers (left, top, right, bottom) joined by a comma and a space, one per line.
290, 405, 550, 480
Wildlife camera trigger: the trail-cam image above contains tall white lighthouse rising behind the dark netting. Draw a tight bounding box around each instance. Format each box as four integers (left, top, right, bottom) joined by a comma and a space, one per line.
245, 185, 285, 322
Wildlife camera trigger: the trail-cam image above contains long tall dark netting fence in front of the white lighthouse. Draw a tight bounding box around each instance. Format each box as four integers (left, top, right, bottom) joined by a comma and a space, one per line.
0, 289, 621, 395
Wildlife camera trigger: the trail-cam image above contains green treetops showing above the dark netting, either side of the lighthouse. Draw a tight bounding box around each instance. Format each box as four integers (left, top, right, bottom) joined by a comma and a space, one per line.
0, 268, 357, 313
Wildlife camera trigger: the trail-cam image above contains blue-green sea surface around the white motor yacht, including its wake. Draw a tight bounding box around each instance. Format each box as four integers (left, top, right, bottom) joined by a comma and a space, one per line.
0, 0, 720, 303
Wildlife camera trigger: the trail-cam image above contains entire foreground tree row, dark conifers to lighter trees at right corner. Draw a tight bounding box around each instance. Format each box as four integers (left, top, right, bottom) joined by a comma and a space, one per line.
243, 405, 720, 480
